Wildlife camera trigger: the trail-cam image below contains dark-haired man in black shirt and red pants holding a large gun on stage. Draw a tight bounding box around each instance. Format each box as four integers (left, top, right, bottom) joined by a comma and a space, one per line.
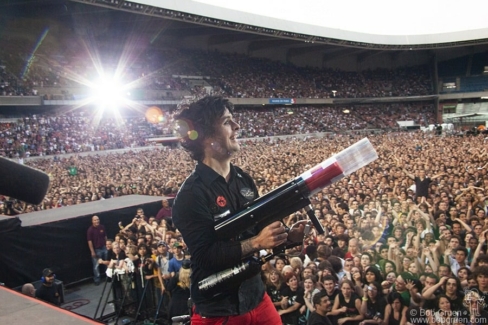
173, 97, 304, 325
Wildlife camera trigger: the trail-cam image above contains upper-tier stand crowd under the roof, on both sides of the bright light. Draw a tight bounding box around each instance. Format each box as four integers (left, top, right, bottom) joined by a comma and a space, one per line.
0, 48, 433, 99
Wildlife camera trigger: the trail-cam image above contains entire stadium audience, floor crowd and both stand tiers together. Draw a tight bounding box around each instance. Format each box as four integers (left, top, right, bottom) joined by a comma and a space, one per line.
0, 9, 488, 325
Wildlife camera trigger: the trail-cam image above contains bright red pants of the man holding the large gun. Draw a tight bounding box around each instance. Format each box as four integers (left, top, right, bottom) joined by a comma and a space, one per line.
191, 293, 282, 325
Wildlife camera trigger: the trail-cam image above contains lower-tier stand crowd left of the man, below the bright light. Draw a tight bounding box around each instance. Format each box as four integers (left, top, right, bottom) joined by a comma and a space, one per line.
0, 111, 169, 157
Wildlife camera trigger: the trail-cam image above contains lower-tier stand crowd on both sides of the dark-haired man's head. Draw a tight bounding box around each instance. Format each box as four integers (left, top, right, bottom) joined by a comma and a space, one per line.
0, 103, 435, 158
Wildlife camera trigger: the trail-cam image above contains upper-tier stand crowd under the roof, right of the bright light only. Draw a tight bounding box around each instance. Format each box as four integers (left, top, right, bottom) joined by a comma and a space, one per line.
191, 52, 433, 98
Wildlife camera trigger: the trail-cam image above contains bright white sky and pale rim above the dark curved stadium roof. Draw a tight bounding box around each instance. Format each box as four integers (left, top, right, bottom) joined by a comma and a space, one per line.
133, 0, 488, 45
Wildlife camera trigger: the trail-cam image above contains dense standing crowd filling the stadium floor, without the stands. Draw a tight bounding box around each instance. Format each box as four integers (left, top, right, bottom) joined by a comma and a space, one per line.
4, 123, 488, 324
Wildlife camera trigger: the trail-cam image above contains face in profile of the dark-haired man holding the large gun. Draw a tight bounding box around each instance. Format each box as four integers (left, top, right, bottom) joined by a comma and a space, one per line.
206, 109, 240, 157
